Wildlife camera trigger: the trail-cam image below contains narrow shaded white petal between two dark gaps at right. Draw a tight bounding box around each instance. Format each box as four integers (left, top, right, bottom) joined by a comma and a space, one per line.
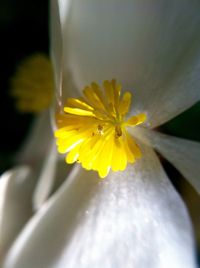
134, 127, 200, 193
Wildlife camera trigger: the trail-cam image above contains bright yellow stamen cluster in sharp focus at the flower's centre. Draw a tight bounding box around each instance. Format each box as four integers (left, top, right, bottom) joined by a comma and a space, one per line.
55, 80, 146, 178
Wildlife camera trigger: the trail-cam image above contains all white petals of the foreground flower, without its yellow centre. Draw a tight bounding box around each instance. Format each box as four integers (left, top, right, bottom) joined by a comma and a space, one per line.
0, 0, 200, 268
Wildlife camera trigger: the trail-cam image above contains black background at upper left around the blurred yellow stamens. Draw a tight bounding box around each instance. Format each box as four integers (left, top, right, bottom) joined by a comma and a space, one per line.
0, 0, 49, 173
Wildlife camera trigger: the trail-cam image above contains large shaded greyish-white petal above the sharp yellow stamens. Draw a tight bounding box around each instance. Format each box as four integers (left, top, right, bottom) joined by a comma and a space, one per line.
63, 0, 200, 127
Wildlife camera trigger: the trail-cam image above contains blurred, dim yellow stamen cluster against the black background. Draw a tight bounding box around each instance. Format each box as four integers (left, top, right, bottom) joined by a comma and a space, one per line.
11, 54, 54, 113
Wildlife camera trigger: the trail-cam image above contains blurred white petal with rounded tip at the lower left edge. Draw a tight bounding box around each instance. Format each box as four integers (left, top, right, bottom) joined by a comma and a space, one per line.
0, 166, 34, 263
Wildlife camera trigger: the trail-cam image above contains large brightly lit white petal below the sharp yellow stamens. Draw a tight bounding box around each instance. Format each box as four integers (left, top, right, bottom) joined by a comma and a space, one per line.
4, 147, 195, 268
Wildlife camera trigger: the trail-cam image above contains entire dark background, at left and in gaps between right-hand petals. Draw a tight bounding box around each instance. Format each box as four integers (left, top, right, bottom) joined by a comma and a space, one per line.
0, 0, 200, 264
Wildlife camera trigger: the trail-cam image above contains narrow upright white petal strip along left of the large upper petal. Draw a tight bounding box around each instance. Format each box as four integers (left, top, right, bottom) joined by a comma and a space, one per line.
50, 0, 77, 112
